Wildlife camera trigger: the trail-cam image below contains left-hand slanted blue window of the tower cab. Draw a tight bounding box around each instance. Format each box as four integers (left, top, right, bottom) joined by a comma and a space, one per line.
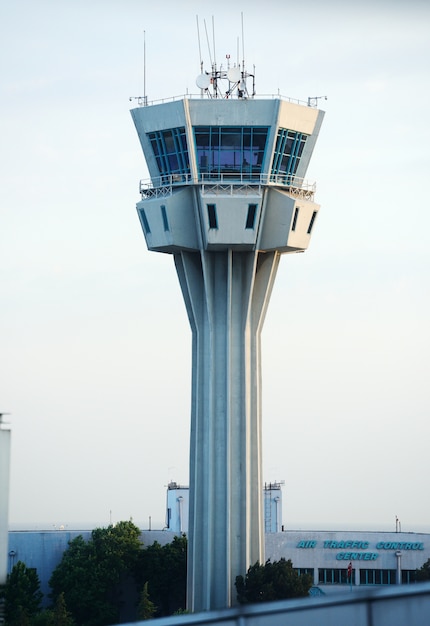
148, 126, 190, 184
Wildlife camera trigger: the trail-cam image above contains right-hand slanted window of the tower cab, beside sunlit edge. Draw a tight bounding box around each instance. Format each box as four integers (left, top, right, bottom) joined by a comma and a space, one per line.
271, 128, 308, 185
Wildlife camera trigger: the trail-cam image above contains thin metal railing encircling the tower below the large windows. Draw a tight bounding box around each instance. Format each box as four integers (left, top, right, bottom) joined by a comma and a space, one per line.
139, 172, 316, 201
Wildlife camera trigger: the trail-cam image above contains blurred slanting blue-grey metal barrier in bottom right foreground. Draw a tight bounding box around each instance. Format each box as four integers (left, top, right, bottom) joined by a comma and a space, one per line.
122, 583, 430, 626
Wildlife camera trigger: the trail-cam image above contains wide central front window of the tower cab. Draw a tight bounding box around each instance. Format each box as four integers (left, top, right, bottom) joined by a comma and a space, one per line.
194, 126, 268, 179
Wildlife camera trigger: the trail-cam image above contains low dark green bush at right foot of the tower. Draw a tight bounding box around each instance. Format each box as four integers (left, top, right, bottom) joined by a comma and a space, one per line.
235, 559, 312, 604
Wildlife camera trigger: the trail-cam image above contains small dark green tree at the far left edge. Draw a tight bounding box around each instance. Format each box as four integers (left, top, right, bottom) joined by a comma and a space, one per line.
4, 561, 43, 626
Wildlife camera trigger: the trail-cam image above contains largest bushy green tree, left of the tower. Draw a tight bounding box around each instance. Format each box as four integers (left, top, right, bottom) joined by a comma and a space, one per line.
49, 522, 142, 626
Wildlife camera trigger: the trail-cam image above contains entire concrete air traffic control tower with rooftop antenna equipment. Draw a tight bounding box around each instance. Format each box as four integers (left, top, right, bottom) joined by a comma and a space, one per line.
131, 66, 324, 612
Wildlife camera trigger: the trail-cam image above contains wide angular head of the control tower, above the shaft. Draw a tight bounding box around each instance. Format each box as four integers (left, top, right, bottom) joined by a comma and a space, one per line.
132, 98, 323, 253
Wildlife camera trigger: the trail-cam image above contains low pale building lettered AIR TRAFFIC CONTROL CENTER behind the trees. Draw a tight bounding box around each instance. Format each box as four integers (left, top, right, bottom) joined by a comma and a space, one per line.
8, 529, 430, 604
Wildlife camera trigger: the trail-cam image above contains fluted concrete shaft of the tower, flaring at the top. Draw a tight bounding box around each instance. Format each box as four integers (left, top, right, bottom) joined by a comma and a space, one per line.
175, 249, 280, 612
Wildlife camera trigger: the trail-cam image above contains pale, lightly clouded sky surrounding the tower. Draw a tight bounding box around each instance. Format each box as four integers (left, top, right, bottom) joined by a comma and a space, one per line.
0, 0, 430, 532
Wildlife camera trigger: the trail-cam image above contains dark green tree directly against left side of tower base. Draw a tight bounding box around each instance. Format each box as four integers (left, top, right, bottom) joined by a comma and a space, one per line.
136, 535, 187, 617
